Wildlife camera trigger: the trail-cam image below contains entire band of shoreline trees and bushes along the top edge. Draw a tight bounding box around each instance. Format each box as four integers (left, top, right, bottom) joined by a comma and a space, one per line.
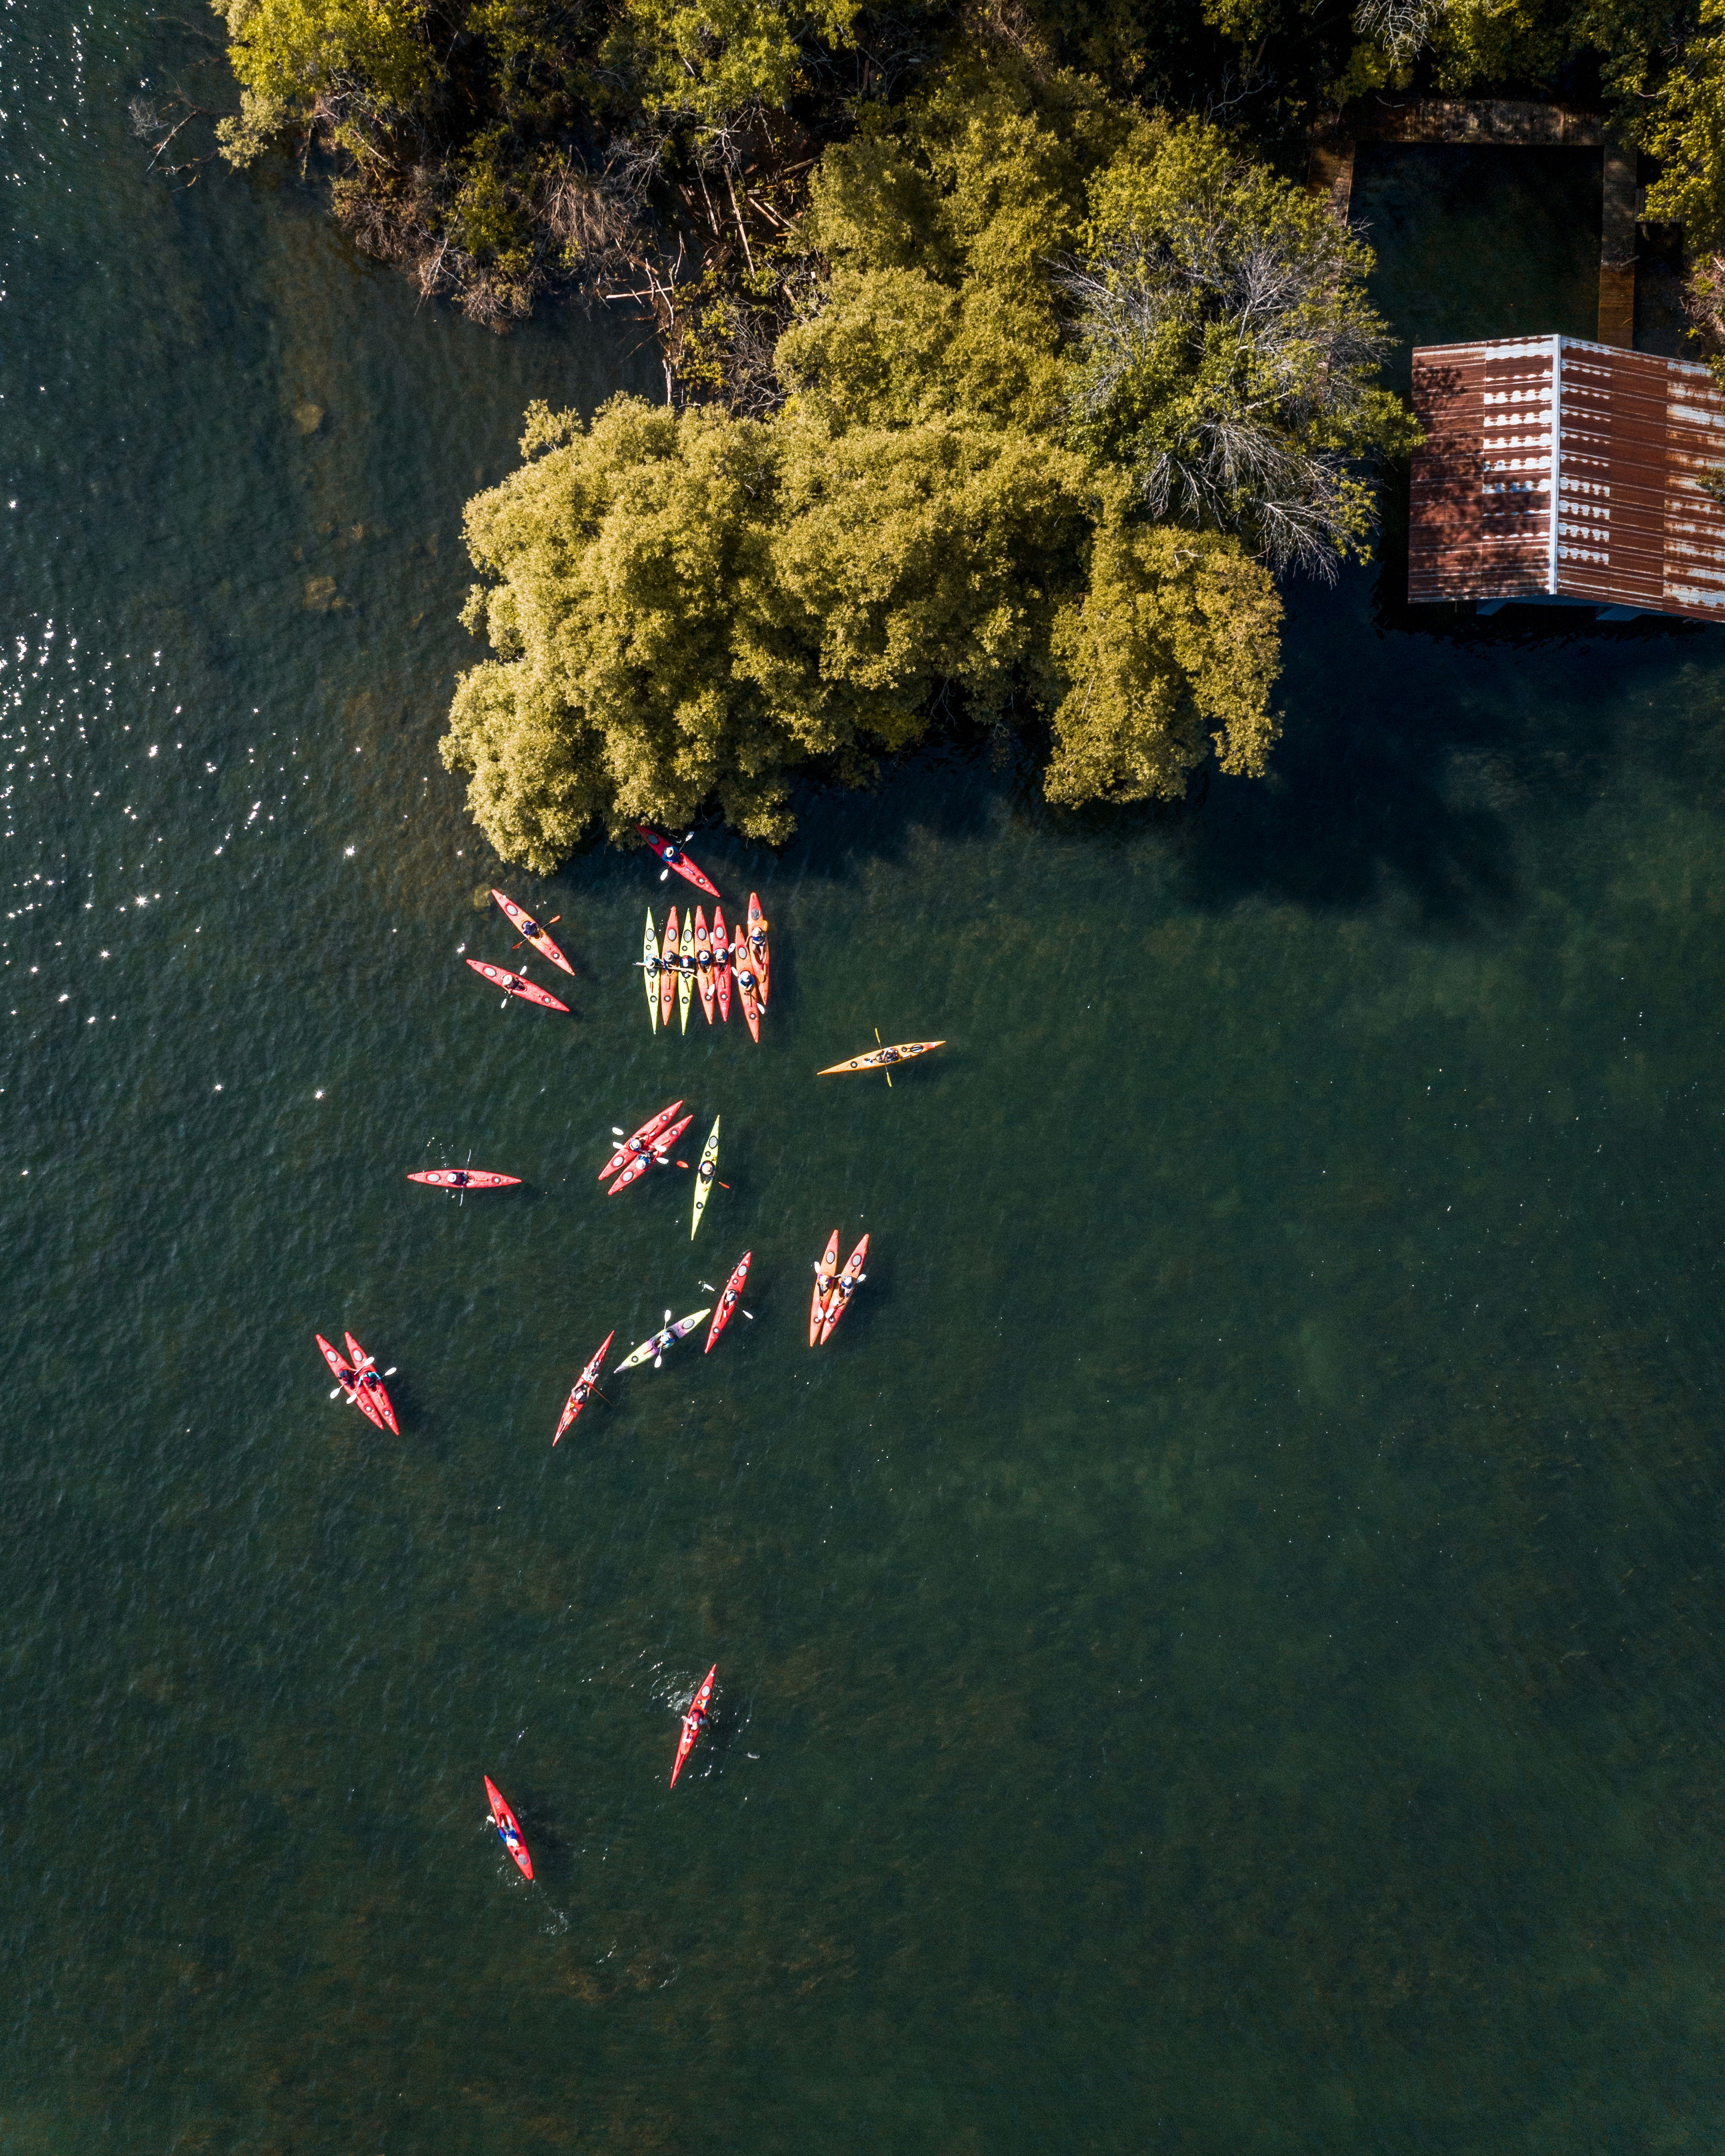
198, 0, 1725, 869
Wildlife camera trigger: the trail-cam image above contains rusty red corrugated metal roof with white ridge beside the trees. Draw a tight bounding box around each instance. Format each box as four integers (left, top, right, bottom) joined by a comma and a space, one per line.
1408, 336, 1725, 621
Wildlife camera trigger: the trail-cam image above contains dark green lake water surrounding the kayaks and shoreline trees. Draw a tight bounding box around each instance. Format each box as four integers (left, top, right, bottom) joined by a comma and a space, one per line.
0, 21, 1725, 2156
